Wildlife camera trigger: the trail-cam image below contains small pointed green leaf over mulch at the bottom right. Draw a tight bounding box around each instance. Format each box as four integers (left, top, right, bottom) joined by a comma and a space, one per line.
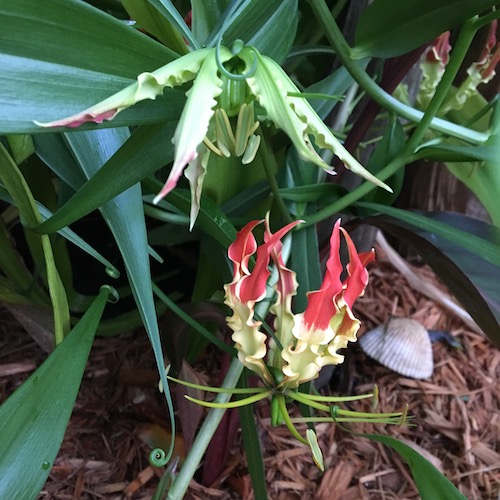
361, 434, 467, 500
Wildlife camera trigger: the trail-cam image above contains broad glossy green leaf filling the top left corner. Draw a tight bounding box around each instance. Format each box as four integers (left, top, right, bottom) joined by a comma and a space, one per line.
0, 0, 179, 133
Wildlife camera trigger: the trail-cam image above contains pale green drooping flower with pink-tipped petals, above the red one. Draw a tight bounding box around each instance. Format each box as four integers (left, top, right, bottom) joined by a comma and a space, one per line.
35, 41, 391, 227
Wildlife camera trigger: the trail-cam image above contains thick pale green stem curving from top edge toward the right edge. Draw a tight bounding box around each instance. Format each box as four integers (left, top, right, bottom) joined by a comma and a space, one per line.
309, 0, 488, 143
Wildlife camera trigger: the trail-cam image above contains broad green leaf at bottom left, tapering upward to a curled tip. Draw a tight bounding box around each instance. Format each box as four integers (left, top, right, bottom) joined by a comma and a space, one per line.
0, 289, 108, 500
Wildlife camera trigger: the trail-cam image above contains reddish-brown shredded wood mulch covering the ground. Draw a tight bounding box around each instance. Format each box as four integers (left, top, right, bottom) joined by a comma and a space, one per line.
0, 248, 500, 500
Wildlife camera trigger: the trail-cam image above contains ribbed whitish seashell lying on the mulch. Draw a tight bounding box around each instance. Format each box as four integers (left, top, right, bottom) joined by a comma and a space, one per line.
359, 318, 434, 379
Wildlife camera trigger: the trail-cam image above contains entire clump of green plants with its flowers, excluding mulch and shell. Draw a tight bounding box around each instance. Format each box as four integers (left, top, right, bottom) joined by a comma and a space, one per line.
0, 0, 500, 499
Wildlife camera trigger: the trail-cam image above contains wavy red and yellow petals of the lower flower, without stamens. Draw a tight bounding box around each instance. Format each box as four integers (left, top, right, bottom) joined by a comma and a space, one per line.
225, 213, 374, 390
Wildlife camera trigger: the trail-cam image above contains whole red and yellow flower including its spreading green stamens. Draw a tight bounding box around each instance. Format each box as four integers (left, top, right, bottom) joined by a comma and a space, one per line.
169, 214, 411, 470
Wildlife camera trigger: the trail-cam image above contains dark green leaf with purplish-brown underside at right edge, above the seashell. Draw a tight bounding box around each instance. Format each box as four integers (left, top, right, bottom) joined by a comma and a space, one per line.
366, 207, 500, 347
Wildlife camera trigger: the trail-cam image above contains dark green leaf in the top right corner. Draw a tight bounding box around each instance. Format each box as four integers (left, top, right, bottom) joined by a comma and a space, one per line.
352, 0, 498, 59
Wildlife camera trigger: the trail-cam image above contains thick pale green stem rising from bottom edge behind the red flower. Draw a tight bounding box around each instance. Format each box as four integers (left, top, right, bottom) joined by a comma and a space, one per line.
167, 358, 243, 500
